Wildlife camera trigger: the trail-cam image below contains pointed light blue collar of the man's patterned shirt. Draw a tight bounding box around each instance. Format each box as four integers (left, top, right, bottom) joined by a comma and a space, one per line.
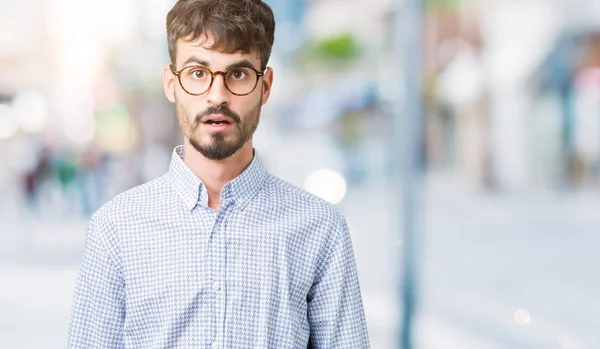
169, 145, 267, 210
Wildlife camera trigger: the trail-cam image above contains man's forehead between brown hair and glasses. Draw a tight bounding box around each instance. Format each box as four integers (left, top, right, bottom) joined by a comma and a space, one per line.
176, 35, 260, 69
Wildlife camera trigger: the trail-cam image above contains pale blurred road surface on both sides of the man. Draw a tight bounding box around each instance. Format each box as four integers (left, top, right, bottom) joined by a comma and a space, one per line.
0, 177, 600, 349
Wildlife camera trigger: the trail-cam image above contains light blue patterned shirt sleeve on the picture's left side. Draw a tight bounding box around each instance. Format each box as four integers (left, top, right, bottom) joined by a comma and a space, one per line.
69, 213, 125, 349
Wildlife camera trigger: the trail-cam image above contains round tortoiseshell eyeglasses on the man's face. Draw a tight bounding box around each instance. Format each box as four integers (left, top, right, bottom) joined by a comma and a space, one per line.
171, 65, 264, 96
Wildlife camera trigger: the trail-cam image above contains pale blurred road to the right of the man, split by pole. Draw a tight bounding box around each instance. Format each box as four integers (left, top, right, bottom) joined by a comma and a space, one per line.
342, 176, 600, 349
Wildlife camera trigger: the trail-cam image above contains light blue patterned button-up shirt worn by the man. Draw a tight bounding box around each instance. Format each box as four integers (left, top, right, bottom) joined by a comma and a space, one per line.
69, 147, 369, 349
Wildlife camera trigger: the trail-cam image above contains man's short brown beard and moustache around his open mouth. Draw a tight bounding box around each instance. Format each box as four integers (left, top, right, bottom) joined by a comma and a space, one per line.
177, 101, 262, 161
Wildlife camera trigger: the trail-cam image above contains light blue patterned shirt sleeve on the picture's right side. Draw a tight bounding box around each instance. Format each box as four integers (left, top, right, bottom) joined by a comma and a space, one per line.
307, 218, 370, 349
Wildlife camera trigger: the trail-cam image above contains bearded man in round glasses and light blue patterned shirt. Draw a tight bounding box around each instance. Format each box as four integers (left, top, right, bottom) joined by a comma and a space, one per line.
69, 0, 369, 349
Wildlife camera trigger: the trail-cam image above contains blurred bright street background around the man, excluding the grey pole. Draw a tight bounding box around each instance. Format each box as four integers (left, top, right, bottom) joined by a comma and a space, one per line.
0, 0, 600, 349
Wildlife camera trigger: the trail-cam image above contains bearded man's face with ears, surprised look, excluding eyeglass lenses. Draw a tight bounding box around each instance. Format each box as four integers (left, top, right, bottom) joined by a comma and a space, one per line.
163, 36, 273, 160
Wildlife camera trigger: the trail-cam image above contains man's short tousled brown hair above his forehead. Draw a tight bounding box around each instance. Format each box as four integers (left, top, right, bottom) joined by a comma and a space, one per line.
167, 0, 275, 70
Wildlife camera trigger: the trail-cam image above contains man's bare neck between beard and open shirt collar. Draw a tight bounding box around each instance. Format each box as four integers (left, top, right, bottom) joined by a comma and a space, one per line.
183, 139, 254, 210
